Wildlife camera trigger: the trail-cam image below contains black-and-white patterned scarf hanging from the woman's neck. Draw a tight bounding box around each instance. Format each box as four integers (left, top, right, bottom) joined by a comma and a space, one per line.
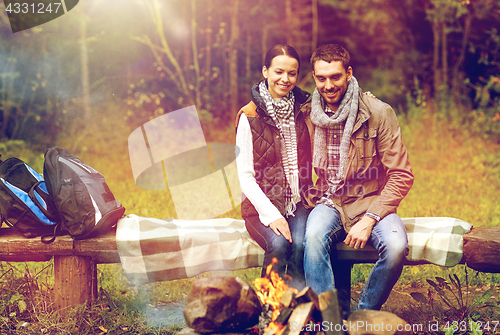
259, 81, 300, 215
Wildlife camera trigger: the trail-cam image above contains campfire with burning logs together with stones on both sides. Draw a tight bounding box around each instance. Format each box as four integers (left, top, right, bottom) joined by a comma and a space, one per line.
182, 268, 411, 335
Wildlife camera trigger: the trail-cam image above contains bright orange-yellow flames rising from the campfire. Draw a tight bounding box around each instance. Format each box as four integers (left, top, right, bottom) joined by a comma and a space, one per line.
254, 258, 298, 331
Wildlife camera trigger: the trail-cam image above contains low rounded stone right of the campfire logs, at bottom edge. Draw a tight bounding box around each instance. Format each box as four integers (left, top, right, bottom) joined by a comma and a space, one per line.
345, 309, 412, 335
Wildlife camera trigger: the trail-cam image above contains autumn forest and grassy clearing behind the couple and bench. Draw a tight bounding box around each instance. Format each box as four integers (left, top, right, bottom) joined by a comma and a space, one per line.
0, 0, 500, 334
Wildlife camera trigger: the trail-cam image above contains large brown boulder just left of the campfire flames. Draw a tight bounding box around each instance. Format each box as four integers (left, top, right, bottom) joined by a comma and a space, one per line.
184, 277, 262, 333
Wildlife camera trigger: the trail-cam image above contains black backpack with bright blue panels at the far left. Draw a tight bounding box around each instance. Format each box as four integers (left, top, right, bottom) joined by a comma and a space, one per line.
0, 157, 62, 243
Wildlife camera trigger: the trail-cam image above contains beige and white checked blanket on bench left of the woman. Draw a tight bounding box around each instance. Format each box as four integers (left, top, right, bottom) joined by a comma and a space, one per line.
116, 214, 264, 285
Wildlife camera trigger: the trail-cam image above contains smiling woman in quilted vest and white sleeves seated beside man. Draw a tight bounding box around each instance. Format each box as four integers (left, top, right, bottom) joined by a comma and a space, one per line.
236, 45, 312, 290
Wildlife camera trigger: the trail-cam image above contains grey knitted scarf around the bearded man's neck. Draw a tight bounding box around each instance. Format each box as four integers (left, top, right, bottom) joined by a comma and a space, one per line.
311, 76, 359, 192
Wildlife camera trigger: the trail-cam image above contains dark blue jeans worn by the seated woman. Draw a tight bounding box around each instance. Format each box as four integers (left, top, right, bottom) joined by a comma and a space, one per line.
245, 202, 310, 290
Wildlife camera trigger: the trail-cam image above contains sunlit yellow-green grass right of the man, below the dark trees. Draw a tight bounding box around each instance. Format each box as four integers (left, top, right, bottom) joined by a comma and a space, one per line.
398, 97, 500, 227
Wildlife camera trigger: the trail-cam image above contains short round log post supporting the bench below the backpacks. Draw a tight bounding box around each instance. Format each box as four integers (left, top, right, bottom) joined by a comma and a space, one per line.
54, 256, 97, 310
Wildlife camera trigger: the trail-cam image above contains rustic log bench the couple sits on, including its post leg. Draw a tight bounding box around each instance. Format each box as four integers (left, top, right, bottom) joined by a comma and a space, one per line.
0, 228, 500, 316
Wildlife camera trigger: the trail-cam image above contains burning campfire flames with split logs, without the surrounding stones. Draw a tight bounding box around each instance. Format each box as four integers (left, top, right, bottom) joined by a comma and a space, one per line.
254, 259, 342, 335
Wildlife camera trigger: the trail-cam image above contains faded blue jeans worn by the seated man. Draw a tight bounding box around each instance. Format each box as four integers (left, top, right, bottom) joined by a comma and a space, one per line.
304, 204, 408, 310
